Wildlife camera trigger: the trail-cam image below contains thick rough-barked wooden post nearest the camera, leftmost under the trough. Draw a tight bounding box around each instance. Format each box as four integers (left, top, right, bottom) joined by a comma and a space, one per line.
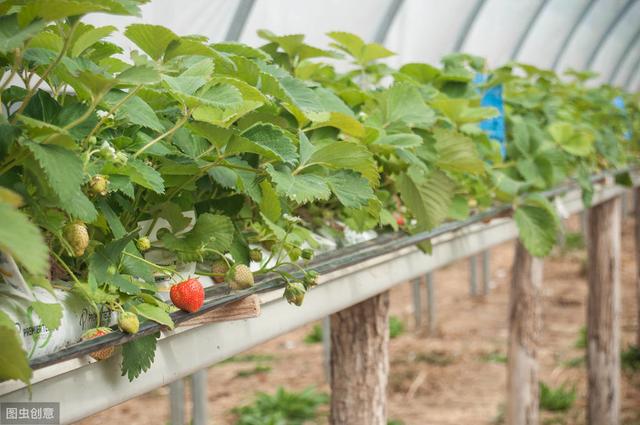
330, 292, 389, 425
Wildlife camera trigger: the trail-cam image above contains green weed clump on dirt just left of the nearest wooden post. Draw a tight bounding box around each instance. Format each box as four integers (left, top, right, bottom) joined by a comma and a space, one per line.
232, 387, 329, 425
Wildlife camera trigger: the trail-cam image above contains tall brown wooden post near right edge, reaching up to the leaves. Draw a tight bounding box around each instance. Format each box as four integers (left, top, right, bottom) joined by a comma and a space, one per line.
587, 197, 621, 425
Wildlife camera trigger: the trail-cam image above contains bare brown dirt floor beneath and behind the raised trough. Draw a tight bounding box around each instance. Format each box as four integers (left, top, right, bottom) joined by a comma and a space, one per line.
79, 215, 640, 425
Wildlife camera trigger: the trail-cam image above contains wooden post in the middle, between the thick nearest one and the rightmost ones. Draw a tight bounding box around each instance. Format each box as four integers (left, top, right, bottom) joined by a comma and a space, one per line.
506, 241, 543, 425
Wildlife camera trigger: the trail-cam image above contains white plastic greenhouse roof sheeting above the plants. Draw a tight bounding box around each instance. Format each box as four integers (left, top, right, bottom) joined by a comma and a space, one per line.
89, 0, 640, 90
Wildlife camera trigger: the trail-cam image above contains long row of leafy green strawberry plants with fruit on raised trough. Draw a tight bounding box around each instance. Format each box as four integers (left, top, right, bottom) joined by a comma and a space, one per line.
0, 0, 640, 382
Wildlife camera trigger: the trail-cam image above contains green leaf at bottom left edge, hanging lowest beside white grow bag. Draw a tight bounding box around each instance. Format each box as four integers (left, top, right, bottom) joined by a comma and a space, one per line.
0, 311, 32, 384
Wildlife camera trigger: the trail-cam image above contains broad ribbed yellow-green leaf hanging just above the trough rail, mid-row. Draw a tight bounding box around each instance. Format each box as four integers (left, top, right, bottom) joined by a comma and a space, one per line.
397, 169, 455, 231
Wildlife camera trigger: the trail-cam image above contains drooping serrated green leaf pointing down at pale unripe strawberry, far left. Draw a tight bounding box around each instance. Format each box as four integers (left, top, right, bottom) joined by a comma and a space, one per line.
25, 142, 98, 222
